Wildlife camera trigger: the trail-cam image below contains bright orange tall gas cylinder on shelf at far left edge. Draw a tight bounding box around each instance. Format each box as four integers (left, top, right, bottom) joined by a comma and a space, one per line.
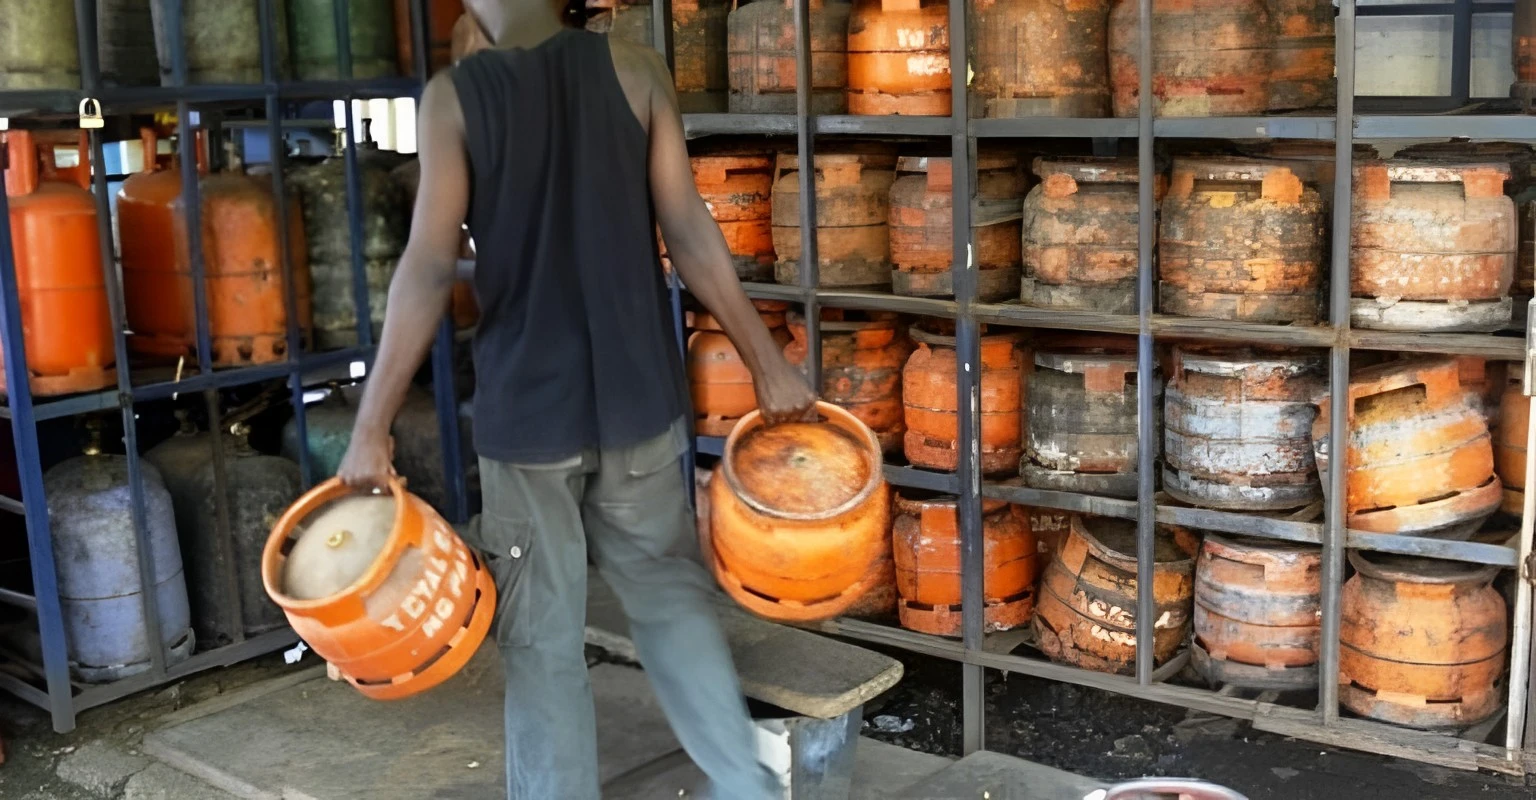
0, 131, 117, 395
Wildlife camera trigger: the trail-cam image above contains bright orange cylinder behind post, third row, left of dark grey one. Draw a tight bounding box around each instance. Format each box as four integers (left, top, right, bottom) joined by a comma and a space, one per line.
902, 330, 1023, 474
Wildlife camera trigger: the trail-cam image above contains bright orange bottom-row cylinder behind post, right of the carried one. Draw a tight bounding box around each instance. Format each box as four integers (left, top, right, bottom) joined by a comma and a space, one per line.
891, 494, 1040, 636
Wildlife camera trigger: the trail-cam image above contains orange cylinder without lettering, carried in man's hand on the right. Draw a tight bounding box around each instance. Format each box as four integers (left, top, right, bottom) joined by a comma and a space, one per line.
705, 402, 891, 622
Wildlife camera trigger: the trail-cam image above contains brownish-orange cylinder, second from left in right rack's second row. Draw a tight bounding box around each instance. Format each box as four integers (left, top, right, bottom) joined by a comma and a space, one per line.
774, 148, 895, 289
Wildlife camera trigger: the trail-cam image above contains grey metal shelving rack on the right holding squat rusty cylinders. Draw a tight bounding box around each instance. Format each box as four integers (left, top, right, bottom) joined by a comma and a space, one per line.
666, 0, 1536, 777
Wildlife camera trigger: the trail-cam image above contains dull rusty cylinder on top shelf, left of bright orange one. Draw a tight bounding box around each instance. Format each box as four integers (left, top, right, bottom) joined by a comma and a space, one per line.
727, 0, 852, 114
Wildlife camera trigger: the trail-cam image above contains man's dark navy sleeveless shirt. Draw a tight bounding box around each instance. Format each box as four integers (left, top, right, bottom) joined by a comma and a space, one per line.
453, 29, 688, 464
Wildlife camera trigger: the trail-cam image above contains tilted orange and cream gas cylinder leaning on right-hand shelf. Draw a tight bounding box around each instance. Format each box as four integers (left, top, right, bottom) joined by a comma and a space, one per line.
1312, 356, 1502, 539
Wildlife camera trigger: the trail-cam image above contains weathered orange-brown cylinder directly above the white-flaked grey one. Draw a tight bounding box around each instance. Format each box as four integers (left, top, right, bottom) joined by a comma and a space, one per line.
1158, 158, 1326, 324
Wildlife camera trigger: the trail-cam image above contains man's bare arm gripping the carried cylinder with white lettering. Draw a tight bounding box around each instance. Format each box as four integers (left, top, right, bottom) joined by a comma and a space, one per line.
338, 72, 470, 487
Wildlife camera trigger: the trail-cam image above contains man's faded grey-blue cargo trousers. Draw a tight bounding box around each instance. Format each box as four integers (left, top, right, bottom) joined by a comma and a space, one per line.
470, 428, 779, 800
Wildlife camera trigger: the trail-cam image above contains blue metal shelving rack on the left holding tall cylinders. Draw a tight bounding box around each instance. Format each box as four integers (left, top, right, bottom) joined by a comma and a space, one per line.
0, 0, 467, 732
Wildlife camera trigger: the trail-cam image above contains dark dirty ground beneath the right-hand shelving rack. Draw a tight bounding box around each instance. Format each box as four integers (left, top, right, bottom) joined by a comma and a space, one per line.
863, 651, 1536, 800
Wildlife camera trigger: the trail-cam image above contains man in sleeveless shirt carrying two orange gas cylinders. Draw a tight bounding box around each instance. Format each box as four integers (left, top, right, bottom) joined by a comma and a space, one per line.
339, 0, 816, 800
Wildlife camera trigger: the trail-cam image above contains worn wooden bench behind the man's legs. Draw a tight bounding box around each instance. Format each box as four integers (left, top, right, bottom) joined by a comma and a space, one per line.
587, 570, 902, 800
